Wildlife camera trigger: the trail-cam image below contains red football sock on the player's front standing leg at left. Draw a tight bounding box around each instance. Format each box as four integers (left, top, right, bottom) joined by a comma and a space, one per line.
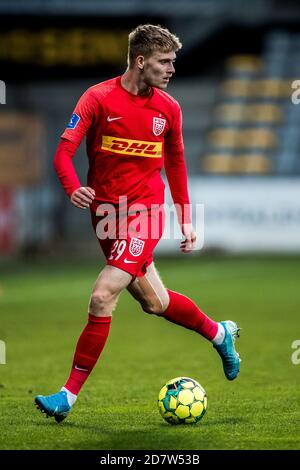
64, 315, 111, 395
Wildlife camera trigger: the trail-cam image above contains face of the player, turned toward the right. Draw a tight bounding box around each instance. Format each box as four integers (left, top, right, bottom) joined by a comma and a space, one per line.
143, 52, 176, 89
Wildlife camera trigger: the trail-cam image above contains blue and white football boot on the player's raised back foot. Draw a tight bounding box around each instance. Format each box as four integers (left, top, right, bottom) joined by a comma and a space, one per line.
214, 320, 241, 380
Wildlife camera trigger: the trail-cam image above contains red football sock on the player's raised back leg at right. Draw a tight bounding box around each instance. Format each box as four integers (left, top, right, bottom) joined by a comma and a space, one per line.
162, 290, 218, 341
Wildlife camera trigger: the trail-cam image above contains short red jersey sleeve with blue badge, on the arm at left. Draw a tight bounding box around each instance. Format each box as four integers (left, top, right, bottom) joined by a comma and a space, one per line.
61, 89, 99, 146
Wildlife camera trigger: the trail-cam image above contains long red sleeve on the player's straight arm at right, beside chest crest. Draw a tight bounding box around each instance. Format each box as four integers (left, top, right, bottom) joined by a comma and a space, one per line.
165, 103, 191, 224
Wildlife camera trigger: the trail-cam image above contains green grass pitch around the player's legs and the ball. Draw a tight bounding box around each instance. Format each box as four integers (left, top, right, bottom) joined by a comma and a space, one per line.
0, 257, 300, 450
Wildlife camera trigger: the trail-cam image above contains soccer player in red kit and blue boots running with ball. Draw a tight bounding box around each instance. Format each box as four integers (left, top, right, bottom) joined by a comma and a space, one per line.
35, 24, 240, 422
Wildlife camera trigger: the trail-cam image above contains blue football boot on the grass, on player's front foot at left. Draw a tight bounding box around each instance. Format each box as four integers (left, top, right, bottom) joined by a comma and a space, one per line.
34, 391, 72, 423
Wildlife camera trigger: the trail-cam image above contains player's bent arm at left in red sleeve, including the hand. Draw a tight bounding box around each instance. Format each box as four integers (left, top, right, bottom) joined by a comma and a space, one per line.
54, 90, 97, 209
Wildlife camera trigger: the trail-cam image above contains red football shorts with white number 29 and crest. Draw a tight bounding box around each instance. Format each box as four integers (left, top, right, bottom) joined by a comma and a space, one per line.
91, 206, 165, 279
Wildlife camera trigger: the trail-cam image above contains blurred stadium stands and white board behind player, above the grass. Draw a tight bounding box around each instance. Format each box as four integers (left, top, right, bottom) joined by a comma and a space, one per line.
0, 0, 300, 258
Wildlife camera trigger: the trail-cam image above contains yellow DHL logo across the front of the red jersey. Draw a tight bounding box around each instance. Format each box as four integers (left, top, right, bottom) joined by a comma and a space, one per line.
101, 135, 162, 158
